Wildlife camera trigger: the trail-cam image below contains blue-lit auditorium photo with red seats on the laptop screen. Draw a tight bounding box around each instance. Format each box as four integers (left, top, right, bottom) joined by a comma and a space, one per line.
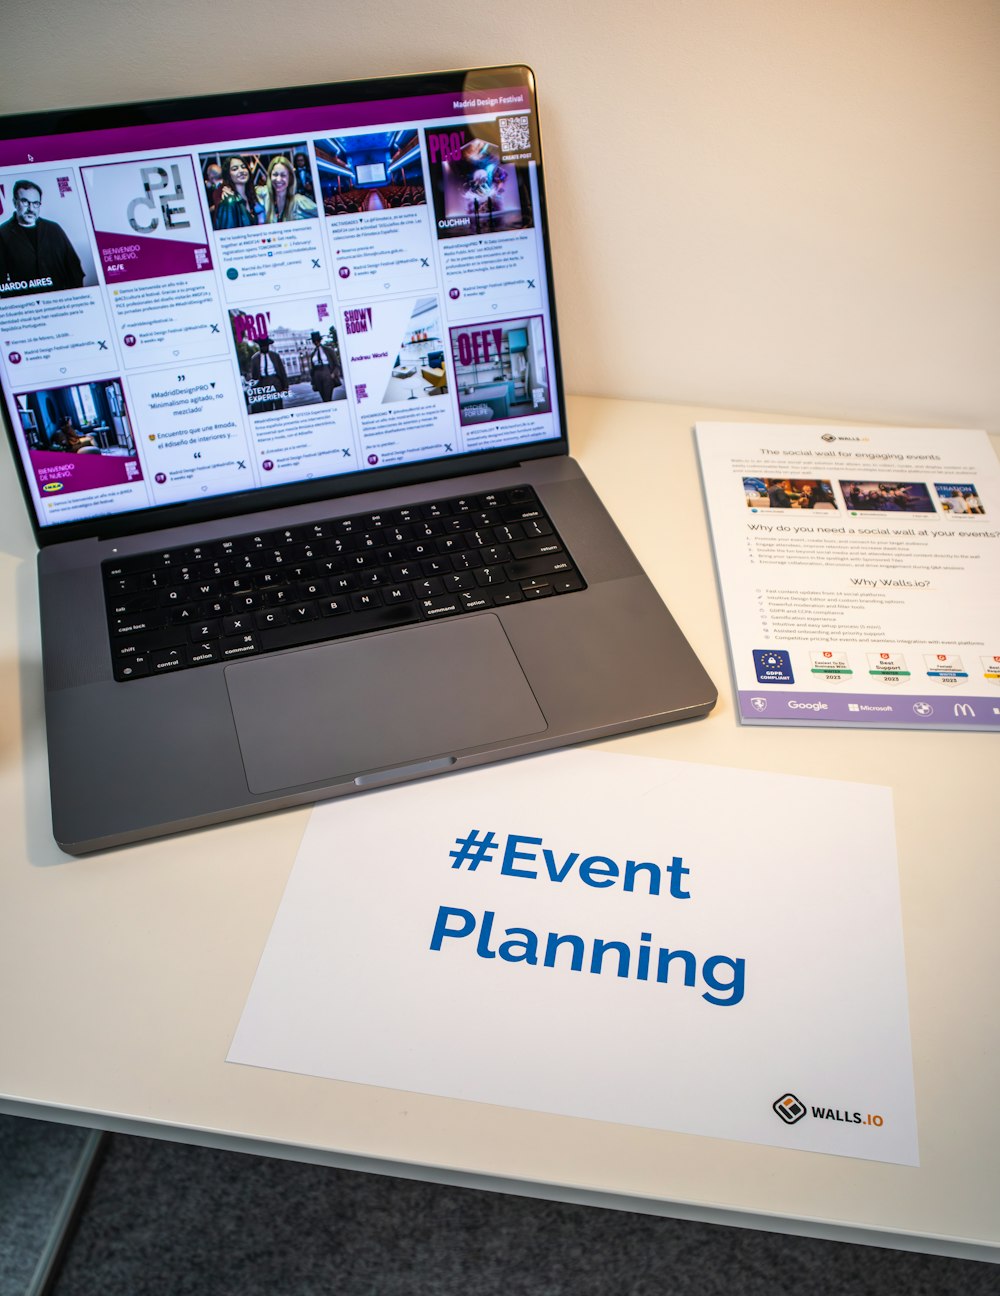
316, 131, 427, 216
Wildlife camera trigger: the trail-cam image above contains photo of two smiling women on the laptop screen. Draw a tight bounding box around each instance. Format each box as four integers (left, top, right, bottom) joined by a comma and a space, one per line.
198, 140, 319, 233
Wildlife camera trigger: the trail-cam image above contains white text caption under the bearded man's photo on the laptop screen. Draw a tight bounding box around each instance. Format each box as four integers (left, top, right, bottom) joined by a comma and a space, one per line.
0, 289, 118, 386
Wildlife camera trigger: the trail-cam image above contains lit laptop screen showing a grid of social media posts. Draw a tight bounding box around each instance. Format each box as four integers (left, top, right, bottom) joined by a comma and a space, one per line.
0, 67, 563, 535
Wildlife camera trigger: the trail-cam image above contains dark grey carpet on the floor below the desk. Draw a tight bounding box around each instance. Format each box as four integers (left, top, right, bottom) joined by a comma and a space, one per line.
0, 1121, 1000, 1296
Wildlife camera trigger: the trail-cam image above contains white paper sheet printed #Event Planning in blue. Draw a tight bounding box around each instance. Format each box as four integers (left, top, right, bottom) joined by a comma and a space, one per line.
228, 752, 917, 1165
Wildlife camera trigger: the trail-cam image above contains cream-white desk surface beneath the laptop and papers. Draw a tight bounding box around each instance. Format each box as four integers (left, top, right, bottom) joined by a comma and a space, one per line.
0, 398, 1000, 1260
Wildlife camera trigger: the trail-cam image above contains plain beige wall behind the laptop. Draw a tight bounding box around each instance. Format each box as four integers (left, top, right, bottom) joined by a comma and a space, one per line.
0, 0, 1000, 430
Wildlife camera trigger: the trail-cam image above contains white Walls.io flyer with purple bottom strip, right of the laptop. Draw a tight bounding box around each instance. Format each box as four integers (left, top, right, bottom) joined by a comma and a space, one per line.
696, 422, 1000, 730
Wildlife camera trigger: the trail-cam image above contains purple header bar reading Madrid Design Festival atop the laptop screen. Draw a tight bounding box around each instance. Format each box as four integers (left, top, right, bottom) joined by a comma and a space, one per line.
0, 86, 531, 166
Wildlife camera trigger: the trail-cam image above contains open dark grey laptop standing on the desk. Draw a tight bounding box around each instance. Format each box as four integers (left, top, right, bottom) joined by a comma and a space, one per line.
0, 66, 716, 854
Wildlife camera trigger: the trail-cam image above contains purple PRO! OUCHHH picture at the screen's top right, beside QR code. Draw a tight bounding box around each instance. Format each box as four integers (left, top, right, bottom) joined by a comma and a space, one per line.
425, 115, 544, 241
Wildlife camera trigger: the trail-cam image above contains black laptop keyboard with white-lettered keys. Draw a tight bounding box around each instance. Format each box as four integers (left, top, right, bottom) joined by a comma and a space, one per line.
101, 486, 585, 680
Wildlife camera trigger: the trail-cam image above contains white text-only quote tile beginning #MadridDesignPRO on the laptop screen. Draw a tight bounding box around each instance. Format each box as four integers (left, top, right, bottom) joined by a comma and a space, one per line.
128, 360, 255, 504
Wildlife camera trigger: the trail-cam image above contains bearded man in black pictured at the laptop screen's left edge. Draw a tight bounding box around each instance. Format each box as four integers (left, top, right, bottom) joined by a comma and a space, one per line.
0, 180, 84, 299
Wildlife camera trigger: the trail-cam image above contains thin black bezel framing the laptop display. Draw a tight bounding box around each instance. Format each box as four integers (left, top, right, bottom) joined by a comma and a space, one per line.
0, 65, 569, 547
